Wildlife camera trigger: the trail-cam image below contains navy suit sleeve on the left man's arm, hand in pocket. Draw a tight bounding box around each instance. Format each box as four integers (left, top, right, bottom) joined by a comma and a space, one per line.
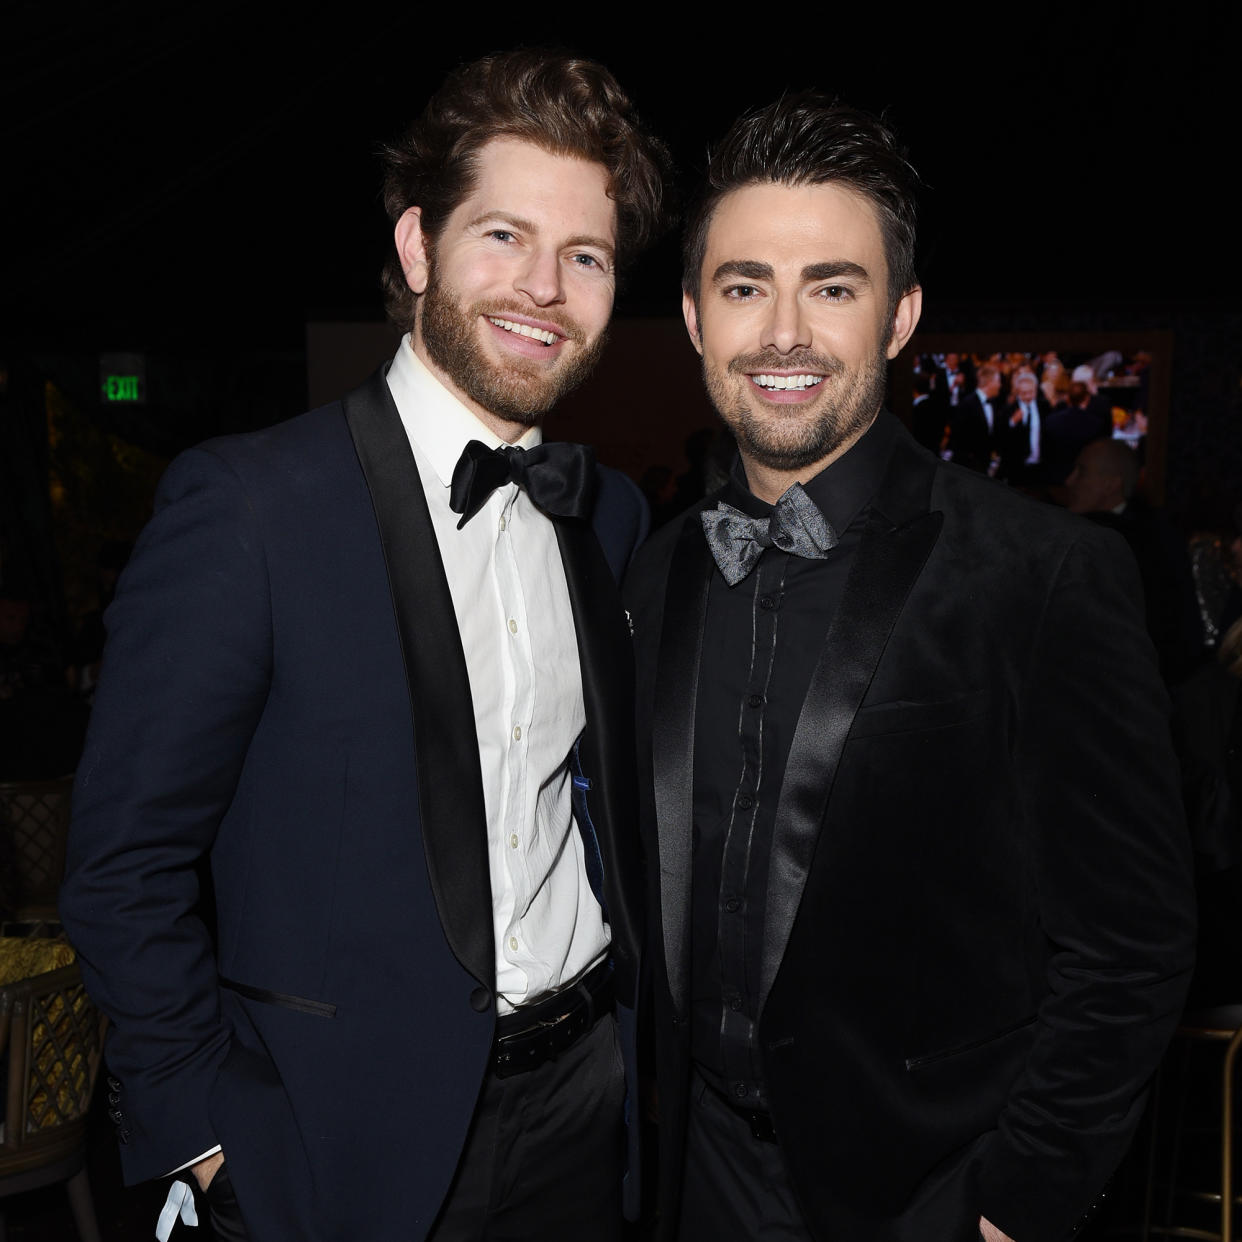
61, 450, 271, 1182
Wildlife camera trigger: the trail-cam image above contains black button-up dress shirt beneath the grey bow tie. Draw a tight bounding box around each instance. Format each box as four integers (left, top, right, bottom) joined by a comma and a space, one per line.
691, 414, 895, 1110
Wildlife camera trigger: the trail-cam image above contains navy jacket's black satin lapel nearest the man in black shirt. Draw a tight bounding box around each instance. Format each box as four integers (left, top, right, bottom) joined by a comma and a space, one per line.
553, 519, 642, 987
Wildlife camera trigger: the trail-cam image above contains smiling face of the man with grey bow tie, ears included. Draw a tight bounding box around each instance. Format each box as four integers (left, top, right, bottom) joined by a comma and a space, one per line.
682, 183, 922, 501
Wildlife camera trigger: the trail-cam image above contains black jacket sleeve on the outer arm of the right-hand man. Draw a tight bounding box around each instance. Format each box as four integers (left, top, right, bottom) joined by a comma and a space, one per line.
977, 530, 1195, 1242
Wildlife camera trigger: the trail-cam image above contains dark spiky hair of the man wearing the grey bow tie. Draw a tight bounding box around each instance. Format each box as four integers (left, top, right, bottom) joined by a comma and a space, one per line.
682, 91, 920, 319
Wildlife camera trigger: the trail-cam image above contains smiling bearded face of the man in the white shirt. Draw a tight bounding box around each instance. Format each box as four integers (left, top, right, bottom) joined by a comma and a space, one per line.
396, 138, 616, 441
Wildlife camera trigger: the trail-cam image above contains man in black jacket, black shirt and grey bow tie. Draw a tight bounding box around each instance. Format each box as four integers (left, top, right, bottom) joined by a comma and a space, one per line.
626, 94, 1194, 1242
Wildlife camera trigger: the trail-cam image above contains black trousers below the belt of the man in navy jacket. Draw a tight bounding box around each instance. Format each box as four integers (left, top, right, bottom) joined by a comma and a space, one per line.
427, 1015, 625, 1242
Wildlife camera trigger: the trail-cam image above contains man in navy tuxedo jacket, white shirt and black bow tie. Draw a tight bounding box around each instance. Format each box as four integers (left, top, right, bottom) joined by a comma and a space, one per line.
62, 51, 662, 1242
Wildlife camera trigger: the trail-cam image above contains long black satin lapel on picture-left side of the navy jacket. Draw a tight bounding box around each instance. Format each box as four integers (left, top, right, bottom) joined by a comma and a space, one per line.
344, 373, 496, 987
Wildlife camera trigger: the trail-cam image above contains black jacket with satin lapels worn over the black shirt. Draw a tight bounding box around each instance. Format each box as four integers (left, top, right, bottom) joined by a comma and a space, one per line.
626, 414, 1194, 1242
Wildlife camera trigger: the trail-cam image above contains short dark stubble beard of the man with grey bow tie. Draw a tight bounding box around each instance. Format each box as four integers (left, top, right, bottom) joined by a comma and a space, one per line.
703, 349, 888, 471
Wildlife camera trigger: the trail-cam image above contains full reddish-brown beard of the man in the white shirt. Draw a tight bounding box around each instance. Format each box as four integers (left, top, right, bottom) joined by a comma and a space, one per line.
417, 263, 607, 427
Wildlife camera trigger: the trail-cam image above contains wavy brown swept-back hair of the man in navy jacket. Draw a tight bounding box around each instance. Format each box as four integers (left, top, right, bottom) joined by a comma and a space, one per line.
381, 47, 669, 332
